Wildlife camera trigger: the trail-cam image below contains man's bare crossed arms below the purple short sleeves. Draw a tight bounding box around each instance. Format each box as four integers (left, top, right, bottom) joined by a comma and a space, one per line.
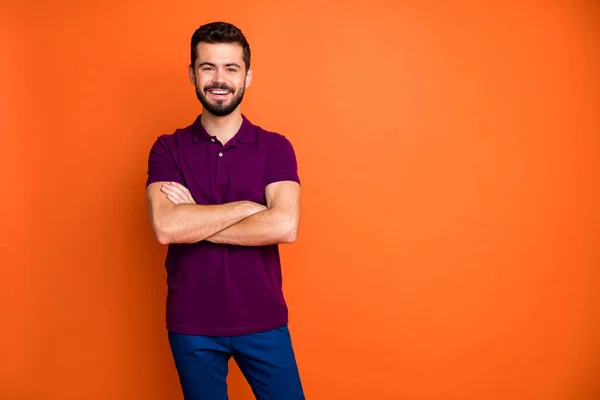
147, 181, 300, 246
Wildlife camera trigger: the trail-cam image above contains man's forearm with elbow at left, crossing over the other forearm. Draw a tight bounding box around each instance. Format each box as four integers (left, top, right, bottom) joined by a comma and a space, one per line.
154, 202, 256, 244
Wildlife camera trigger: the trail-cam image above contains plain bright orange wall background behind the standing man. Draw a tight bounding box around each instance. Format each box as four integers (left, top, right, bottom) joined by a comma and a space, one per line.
0, 0, 600, 400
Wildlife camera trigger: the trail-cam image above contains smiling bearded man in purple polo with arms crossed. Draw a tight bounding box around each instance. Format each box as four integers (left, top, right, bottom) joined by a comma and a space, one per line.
146, 22, 305, 400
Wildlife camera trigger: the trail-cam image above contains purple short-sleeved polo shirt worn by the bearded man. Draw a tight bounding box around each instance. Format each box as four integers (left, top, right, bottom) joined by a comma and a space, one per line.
146, 115, 300, 336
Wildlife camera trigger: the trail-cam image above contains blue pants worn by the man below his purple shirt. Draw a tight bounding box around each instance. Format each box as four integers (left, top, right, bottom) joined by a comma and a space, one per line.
169, 325, 305, 400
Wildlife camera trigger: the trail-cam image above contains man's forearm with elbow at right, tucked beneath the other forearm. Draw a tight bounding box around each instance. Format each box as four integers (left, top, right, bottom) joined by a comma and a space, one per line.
206, 208, 298, 246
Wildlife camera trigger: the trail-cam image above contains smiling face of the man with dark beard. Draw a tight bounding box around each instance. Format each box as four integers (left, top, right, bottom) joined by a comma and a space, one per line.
190, 42, 252, 117
